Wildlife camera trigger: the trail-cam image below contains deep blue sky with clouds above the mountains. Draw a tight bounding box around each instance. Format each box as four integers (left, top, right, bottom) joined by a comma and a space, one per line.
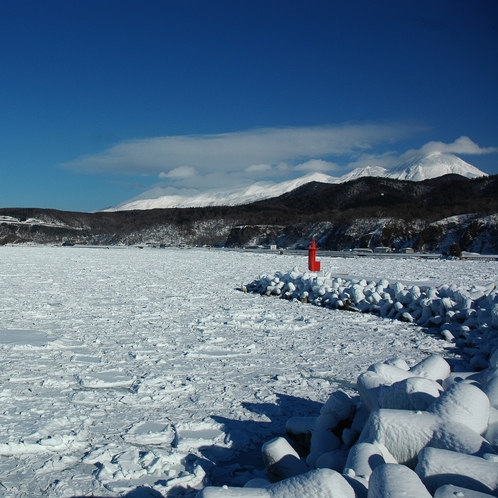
0, 0, 498, 211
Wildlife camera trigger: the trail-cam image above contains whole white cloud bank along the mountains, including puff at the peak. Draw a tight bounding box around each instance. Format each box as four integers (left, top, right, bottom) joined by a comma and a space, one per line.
62, 123, 498, 190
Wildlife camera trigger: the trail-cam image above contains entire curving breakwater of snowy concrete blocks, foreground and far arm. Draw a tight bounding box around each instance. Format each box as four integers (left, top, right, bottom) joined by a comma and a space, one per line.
197, 267, 498, 498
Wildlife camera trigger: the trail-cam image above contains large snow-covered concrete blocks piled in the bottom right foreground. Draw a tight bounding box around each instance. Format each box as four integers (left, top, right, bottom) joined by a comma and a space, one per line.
205, 352, 498, 498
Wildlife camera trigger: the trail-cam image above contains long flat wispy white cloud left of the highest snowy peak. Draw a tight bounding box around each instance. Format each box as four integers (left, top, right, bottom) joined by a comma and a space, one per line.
62, 123, 416, 181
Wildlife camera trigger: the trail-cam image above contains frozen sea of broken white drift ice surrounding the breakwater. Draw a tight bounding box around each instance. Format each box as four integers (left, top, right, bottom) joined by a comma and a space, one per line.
0, 247, 498, 497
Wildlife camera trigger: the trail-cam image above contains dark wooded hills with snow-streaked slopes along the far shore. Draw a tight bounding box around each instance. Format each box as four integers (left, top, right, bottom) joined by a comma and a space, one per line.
0, 174, 498, 254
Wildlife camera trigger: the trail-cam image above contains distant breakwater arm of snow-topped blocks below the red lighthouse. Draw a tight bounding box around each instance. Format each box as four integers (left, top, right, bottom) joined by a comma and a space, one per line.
241, 267, 498, 370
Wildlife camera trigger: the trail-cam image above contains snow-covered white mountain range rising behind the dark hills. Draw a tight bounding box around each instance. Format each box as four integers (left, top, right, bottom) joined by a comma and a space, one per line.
105, 152, 487, 211
